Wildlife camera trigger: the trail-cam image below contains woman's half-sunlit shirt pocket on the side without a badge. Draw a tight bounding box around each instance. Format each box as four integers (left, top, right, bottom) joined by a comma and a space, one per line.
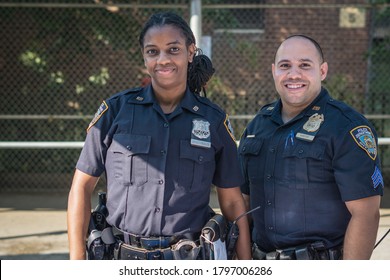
106, 134, 151, 187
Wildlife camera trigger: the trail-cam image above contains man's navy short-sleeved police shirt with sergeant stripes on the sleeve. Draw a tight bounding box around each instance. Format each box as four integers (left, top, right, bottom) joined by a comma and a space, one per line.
239, 88, 384, 251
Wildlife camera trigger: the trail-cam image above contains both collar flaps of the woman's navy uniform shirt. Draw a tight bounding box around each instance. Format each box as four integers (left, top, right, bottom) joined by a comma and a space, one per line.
128, 85, 205, 116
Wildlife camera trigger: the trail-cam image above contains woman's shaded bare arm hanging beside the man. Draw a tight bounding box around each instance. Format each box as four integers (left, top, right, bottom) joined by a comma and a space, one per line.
217, 187, 252, 260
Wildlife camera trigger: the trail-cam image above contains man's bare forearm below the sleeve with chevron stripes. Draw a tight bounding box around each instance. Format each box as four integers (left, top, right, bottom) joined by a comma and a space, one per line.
343, 195, 380, 260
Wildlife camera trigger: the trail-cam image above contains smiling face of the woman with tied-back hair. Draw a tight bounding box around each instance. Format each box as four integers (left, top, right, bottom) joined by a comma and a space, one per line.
142, 25, 195, 91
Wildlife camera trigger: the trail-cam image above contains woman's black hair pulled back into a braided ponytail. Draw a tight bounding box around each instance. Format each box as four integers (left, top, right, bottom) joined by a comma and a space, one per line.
138, 12, 215, 94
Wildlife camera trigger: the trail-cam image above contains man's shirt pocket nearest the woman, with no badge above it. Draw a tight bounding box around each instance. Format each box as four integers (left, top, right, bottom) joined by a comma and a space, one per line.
238, 138, 264, 183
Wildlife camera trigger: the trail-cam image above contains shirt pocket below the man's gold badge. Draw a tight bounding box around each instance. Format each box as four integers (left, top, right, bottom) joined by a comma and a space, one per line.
282, 142, 326, 189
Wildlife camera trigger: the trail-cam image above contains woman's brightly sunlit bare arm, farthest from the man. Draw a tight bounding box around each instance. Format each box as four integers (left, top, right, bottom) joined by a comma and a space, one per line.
67, 169, 99, 259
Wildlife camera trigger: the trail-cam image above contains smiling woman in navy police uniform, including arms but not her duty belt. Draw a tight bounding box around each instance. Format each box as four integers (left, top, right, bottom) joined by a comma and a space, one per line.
68, 13, 250, 259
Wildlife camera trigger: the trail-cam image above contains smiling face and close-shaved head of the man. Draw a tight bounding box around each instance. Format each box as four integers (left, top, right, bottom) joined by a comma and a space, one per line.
272, 37, 328, 113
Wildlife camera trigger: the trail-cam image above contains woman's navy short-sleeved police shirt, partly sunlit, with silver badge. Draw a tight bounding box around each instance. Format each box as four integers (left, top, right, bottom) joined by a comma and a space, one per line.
76, 86, 243, 236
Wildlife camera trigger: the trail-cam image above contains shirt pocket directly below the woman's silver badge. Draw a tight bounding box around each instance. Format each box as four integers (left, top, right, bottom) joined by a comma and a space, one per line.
178, 140, 215, 191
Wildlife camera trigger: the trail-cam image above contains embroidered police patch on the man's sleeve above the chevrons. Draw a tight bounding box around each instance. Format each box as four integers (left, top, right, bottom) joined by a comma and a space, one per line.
349, 125, 378, 160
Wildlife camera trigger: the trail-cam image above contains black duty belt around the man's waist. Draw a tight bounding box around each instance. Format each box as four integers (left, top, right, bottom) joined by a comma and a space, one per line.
252, 241, 343, 260
